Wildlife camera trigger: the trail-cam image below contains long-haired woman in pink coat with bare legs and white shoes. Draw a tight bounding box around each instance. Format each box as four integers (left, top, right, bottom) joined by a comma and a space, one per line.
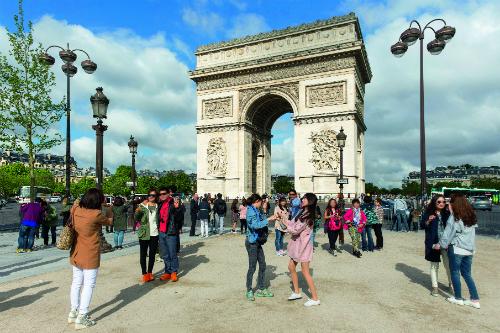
287, 193, 320, 307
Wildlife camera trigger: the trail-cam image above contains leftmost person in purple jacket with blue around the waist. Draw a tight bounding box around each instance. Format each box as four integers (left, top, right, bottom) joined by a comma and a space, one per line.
16, 198, 43, 253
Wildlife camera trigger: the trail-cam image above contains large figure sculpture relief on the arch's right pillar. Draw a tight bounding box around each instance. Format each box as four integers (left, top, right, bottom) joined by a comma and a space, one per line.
310, 129, 340, 173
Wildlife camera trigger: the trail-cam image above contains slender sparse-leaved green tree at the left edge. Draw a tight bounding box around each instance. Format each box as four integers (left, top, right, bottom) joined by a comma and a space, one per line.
0, 0, 64, 201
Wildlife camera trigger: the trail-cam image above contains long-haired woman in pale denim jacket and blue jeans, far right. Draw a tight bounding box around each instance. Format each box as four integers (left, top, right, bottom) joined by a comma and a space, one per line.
435, 194, 481, 309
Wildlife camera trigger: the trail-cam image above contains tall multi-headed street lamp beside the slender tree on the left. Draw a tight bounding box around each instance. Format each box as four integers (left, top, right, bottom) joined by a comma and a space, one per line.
39, 43, 97, 198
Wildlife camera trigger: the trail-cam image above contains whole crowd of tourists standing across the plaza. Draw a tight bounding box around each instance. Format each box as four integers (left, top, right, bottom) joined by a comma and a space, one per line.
12, 187, 480, 329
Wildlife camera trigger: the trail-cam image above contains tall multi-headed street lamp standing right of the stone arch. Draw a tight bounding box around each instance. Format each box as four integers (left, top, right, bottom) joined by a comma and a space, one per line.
391, 18, 455, 206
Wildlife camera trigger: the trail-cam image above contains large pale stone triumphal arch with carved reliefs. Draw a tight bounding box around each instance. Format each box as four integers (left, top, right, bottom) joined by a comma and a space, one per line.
190, 13, 372, 197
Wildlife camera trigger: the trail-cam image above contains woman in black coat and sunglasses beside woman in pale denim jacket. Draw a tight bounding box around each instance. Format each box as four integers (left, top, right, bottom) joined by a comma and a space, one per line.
420, 195, 452, 297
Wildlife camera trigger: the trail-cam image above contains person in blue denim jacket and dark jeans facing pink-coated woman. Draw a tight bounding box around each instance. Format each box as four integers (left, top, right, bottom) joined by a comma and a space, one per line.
245, 193, 276, 301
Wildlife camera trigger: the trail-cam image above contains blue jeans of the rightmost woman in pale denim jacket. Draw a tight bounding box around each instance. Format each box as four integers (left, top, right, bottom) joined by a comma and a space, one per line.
448, 246, 479, 300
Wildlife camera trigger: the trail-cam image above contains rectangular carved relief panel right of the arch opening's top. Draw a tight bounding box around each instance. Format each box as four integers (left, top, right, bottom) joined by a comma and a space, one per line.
306, 81, 347, 108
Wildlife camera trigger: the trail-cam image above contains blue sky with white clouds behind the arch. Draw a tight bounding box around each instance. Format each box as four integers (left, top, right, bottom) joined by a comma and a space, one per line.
0, 0, 500, 186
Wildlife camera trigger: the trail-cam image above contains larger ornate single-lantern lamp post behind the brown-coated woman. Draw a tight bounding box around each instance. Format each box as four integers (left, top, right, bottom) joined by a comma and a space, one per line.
90, 87, 109, 191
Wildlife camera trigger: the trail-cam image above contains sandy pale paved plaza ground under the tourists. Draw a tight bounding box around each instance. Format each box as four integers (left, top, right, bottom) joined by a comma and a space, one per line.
0, 232, 500, 332
